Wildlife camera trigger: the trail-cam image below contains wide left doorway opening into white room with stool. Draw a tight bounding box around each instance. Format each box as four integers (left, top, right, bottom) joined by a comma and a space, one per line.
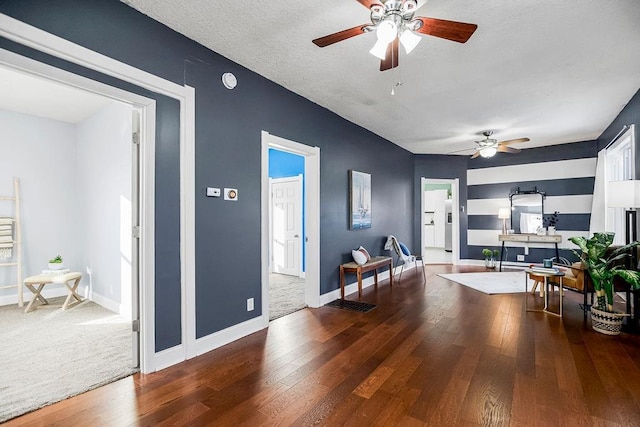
0, 67, 138, 421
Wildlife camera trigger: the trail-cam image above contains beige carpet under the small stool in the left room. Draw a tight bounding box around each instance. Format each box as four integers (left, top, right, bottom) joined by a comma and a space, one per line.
0, 298, 135, 422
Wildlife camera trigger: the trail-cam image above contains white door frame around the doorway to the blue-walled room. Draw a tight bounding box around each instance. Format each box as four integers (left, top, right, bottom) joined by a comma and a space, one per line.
261, 131, 320, 320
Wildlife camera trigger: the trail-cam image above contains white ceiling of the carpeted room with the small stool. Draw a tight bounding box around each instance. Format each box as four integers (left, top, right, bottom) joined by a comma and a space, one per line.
0, 67, 114, 124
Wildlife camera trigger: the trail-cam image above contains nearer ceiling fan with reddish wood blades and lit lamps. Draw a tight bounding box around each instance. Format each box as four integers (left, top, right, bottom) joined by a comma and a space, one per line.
313, 0, 478, 71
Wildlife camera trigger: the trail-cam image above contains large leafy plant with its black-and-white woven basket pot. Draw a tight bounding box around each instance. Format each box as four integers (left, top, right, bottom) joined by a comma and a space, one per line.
569, 233, 640, 335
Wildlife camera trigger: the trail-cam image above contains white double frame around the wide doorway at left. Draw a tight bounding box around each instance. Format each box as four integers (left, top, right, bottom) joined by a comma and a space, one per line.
0, 14, 195, 373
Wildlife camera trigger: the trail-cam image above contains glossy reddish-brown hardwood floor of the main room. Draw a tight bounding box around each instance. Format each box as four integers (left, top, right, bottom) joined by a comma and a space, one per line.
7, 265, 640, 426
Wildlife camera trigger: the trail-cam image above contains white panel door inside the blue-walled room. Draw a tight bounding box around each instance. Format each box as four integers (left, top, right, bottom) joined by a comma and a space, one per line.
271, 175, 302, 276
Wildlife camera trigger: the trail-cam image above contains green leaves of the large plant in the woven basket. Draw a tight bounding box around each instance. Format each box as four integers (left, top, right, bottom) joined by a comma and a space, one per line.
569, 233, 640, 312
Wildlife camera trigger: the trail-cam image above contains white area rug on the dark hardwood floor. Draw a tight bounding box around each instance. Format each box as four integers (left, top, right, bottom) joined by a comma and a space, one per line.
438, 271, 525, 294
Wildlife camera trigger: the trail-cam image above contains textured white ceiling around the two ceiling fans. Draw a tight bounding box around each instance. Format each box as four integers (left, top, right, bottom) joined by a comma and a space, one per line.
124, 0, 640, 154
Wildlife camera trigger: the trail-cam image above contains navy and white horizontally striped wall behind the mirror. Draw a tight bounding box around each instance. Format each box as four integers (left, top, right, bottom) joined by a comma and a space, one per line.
467, 150, 597, 262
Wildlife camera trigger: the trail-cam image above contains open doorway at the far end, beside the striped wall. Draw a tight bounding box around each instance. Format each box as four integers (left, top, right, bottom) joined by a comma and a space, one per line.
420, 178, 460, 264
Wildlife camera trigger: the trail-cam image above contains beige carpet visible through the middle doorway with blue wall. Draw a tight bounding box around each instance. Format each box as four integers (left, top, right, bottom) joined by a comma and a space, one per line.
269, 273, 307, 320
